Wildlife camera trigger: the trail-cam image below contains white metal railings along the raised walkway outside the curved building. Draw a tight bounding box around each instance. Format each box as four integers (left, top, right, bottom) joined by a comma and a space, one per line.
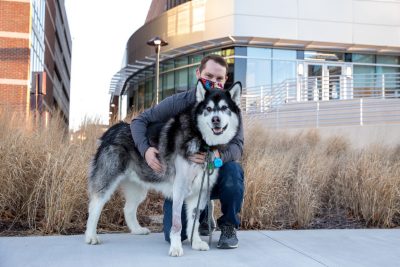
241, 73, 400, 128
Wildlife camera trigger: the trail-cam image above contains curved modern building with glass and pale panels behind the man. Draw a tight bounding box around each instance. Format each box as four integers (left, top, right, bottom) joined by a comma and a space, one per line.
110, 0, 400, 136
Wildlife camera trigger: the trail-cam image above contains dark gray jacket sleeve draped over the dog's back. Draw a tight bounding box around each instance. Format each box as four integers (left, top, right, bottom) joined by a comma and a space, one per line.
130, 91, 194, 158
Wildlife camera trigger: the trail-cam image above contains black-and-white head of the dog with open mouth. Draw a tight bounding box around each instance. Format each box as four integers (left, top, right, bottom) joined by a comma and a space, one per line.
196, 81, 242, 146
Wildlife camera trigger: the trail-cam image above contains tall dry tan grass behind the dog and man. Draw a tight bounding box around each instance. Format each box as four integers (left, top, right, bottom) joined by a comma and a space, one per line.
0, 111, 400, 234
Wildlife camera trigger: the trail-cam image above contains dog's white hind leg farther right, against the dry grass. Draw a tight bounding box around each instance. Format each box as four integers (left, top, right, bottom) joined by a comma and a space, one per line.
121, 181, 150, 235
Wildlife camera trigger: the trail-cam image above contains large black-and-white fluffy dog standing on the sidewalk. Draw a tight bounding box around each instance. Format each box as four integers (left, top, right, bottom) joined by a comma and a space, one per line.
85, 80, 242, 256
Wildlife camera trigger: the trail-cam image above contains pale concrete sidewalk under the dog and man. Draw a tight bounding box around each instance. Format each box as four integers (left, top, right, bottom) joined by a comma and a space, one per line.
0, 229, 400, 267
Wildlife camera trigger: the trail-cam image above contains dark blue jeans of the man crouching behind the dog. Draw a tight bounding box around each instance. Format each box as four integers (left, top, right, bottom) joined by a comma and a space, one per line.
163, 161, 244, 242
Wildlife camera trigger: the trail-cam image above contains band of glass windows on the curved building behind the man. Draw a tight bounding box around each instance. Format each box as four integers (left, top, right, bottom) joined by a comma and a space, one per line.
127, 46, 400, 110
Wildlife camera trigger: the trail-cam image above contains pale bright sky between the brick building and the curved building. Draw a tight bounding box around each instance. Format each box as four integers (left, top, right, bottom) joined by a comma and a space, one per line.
65, 0, 151, 130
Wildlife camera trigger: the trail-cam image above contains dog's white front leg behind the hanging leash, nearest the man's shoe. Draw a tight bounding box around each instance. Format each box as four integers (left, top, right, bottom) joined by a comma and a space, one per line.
185, 191, 210, 250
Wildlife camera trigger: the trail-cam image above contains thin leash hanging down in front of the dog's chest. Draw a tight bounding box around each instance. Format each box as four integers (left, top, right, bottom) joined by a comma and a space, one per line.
190, 150, 214, 247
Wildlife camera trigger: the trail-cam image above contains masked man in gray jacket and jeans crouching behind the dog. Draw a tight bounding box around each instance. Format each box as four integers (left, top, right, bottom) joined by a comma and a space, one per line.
131, 55, 244, 249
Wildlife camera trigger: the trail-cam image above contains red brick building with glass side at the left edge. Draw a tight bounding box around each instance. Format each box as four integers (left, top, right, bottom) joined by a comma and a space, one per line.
0, 0, 72, 125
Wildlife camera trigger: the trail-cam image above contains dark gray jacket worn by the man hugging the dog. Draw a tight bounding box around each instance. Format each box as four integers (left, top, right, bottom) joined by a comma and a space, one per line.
131, 88, 243, 162
